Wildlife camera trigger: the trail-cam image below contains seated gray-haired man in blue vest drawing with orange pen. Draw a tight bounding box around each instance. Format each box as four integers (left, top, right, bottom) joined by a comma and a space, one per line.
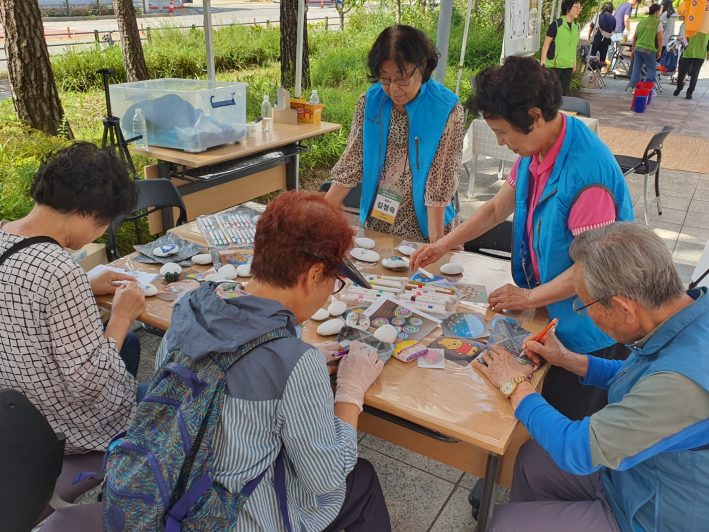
473, 223, 709, 532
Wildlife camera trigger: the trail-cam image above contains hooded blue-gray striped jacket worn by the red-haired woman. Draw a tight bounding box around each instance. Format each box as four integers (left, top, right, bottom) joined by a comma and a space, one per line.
156, 287, 357, 532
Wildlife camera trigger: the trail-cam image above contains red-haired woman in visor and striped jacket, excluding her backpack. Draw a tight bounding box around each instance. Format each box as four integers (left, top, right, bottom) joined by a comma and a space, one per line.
156, 192, 391, 532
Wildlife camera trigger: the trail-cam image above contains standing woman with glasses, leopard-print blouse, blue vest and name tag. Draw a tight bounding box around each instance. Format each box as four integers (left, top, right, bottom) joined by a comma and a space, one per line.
327, 25, 465, 242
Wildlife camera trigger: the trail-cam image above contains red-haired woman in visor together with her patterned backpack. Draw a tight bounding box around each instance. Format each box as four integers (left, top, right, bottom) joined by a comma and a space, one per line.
119, 192, 391, 532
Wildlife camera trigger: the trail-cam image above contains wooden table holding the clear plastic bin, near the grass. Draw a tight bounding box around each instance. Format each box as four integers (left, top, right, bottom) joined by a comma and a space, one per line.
131, 122, 341, 234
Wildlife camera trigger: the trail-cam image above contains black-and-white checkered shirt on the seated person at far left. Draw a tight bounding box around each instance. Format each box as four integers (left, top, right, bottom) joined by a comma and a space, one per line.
0, 229, 136, 454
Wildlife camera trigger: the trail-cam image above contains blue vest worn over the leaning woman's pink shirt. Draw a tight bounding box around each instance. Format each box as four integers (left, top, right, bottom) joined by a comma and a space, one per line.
512, 117, 635, 353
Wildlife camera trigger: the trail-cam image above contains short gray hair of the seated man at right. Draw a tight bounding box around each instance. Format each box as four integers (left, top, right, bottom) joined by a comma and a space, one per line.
569, 222, 684, 310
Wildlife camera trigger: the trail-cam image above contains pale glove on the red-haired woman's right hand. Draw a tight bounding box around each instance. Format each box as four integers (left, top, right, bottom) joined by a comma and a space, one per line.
335, 342, 384, 412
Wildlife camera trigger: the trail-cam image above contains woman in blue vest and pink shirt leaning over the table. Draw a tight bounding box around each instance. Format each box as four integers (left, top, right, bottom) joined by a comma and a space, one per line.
412, 57, 634, 419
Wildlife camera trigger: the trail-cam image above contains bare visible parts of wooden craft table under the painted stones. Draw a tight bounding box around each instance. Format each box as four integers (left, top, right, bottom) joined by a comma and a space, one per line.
98, 204, 549, 531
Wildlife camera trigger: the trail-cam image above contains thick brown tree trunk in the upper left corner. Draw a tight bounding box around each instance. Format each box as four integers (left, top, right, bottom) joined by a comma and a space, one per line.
0, 0, 74, 138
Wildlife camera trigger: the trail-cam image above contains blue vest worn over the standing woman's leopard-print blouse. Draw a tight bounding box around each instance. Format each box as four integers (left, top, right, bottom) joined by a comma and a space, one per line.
359, 79, 460, 238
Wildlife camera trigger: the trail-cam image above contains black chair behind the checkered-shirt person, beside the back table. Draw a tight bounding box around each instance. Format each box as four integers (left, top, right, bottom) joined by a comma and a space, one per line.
106, 179, 187, 261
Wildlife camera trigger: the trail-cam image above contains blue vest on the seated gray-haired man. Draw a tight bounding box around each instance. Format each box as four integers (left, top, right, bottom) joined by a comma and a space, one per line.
601, 288, 709, 532
